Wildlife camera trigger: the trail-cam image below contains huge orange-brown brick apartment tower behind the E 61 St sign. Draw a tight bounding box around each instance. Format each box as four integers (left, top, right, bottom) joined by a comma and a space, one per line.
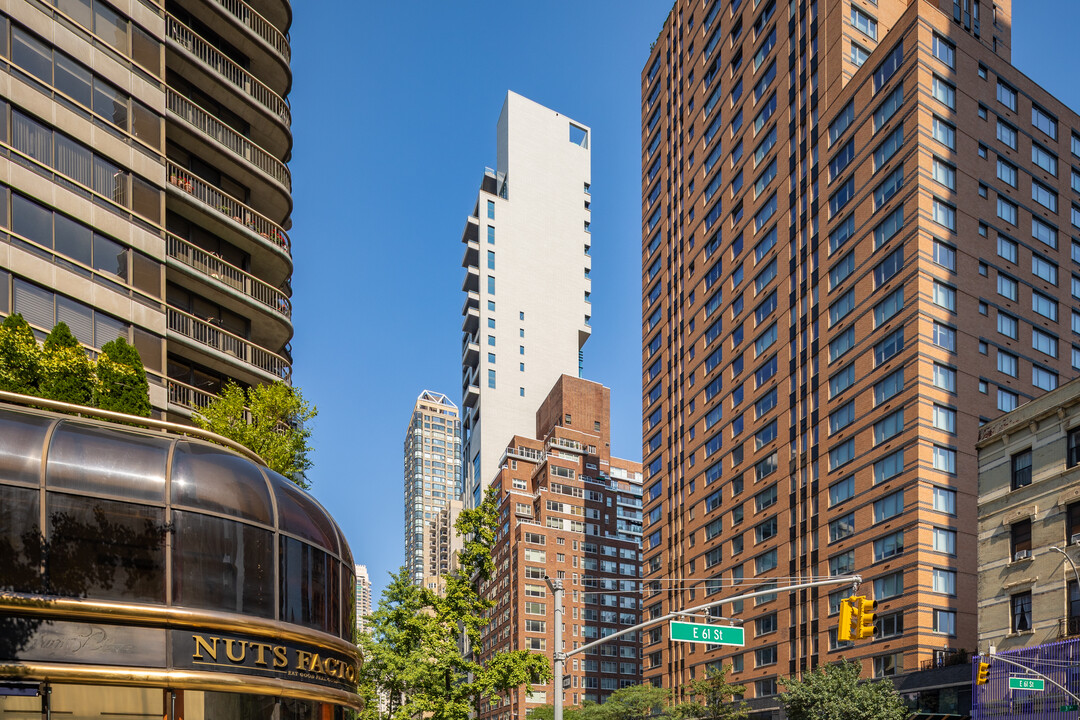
642, 0, 1080, 710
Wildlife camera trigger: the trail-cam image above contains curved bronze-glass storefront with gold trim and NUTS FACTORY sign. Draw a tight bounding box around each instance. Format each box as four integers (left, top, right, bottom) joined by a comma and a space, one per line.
0, 405, 361, 720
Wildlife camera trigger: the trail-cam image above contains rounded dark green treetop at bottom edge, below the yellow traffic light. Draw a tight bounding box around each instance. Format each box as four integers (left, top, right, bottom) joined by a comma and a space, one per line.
780, 661, 908, 720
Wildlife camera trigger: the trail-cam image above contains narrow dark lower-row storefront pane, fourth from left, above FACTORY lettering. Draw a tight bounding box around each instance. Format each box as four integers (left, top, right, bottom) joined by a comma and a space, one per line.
280, 535, 337, 633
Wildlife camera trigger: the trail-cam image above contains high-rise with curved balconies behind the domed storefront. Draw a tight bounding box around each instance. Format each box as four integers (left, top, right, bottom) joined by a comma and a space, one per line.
0, 0, 293, 420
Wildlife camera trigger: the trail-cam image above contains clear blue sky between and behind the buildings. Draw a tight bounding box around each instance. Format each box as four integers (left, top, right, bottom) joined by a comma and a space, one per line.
280, 0, 1080, 601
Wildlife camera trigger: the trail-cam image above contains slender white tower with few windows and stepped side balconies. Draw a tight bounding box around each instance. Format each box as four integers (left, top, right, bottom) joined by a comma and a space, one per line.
461, 93, 592, 505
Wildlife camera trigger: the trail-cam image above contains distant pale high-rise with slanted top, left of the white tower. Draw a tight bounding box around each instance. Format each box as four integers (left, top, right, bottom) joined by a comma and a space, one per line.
404, 390, 461, 589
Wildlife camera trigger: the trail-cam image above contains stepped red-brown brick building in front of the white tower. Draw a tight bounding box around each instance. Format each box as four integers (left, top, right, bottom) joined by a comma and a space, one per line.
477, 375, 642, 720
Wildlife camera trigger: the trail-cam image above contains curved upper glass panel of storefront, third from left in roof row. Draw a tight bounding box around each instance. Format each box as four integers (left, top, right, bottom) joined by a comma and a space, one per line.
172, 440, 273, 527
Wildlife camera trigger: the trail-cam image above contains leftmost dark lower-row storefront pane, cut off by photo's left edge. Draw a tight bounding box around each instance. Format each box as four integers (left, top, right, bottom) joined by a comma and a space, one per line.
0, 485, 41, 591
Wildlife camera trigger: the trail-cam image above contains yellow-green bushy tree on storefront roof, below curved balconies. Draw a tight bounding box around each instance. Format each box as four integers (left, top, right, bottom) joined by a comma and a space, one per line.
193, 380, 319, 488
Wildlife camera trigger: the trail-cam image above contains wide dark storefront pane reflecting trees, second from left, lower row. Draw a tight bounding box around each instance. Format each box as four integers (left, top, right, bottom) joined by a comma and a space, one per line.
45, 492, 167, 604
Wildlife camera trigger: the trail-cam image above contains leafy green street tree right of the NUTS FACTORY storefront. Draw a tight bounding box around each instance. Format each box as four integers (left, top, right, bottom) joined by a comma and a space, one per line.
360, 491, 551, 720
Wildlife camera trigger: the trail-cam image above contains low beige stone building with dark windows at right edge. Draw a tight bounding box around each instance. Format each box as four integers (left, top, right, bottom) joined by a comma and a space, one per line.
978, 380, 1080, 652
